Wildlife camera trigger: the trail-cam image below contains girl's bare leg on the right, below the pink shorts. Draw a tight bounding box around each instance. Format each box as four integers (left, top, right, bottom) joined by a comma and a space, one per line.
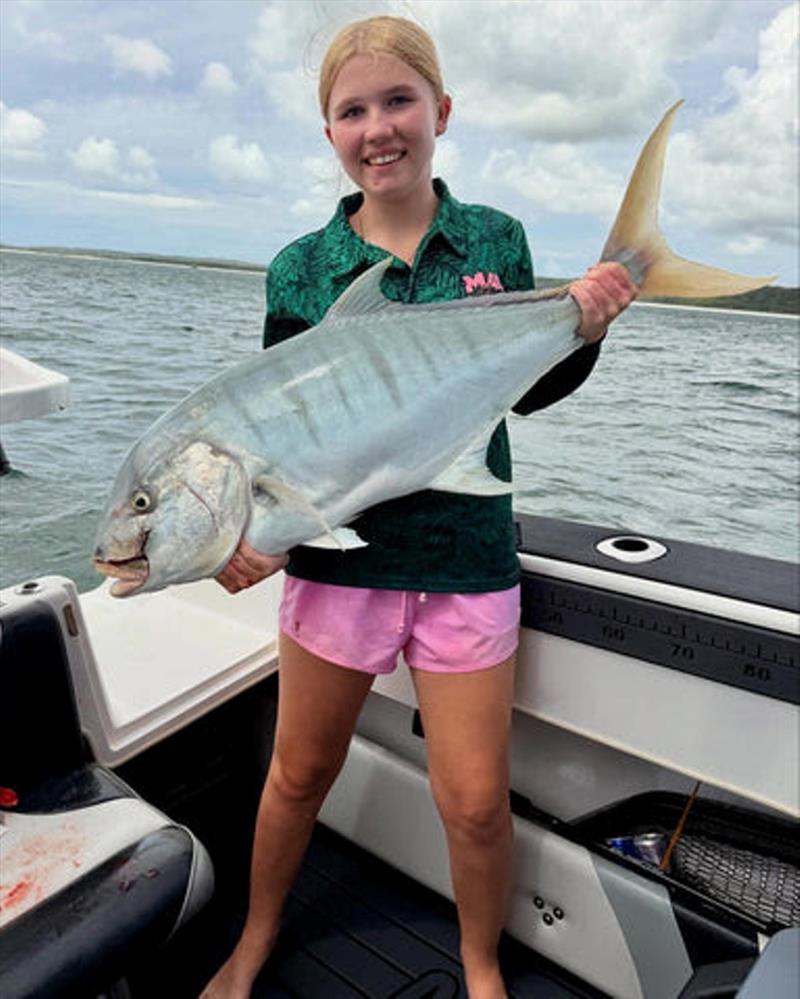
412, 657, 514, 999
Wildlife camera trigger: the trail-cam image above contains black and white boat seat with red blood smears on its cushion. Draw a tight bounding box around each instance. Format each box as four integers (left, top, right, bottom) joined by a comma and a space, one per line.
0, 592, 213, 999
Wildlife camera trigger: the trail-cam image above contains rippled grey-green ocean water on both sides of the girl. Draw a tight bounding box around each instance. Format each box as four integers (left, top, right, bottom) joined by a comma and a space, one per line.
0, 251, 800, 590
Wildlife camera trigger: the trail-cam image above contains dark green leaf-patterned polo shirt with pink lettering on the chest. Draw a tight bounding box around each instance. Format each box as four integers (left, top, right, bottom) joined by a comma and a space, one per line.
264, 180, 596, 593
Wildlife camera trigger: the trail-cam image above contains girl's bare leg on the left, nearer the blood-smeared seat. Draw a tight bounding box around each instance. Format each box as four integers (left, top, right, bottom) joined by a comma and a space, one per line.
201, 634, 373, 999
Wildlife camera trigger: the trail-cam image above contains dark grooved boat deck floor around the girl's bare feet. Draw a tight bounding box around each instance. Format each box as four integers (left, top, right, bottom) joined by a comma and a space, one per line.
130, 825, 603, 999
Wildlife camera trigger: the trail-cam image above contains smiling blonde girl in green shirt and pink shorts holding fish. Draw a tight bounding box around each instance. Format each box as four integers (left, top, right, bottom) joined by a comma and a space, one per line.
202, 17, 635, 999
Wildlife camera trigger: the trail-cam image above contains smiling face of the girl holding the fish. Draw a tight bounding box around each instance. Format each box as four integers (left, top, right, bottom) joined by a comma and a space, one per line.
325, 54, 451, 201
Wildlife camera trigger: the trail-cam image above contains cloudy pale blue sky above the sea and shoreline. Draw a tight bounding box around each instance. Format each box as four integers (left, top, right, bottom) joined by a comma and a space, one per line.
0, 0, 800, 285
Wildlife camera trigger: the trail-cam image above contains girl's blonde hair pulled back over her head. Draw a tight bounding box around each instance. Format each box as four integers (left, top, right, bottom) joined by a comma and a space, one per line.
319, 15, 444, 120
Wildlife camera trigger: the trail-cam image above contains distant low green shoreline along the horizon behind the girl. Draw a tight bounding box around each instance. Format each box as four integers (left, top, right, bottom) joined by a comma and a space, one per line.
0, 243, 800, 319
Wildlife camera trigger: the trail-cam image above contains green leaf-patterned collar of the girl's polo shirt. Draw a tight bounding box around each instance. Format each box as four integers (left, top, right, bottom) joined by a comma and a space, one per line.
324, 177, 466, 276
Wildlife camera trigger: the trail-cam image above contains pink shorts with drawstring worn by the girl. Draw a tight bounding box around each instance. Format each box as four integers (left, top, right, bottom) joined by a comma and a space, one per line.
280, 576, 520, 673
